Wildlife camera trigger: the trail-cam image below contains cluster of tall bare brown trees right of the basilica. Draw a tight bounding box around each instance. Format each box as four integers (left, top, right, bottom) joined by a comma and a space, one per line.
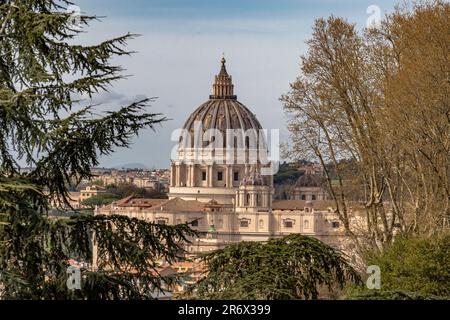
281, 1, 450, 254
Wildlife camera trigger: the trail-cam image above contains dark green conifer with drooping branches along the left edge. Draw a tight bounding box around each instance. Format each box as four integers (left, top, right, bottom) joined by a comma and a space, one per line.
0, 0, 193, 299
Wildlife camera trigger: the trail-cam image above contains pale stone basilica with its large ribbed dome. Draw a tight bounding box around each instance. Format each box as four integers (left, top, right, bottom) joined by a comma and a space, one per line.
96, 58, 356, 253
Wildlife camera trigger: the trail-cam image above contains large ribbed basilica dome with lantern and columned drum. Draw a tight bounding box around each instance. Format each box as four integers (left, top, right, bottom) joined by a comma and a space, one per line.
169, 58, 273, 207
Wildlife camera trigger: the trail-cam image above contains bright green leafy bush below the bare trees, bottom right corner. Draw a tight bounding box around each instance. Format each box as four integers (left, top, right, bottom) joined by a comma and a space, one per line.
349, 234, 450, 299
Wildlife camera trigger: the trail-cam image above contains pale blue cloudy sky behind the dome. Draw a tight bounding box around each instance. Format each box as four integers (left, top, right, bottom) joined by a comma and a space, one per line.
73, 0, 395, 168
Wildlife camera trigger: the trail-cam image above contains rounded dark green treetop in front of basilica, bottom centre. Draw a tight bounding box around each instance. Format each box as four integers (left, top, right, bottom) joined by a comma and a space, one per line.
190, 234, 360, 300
